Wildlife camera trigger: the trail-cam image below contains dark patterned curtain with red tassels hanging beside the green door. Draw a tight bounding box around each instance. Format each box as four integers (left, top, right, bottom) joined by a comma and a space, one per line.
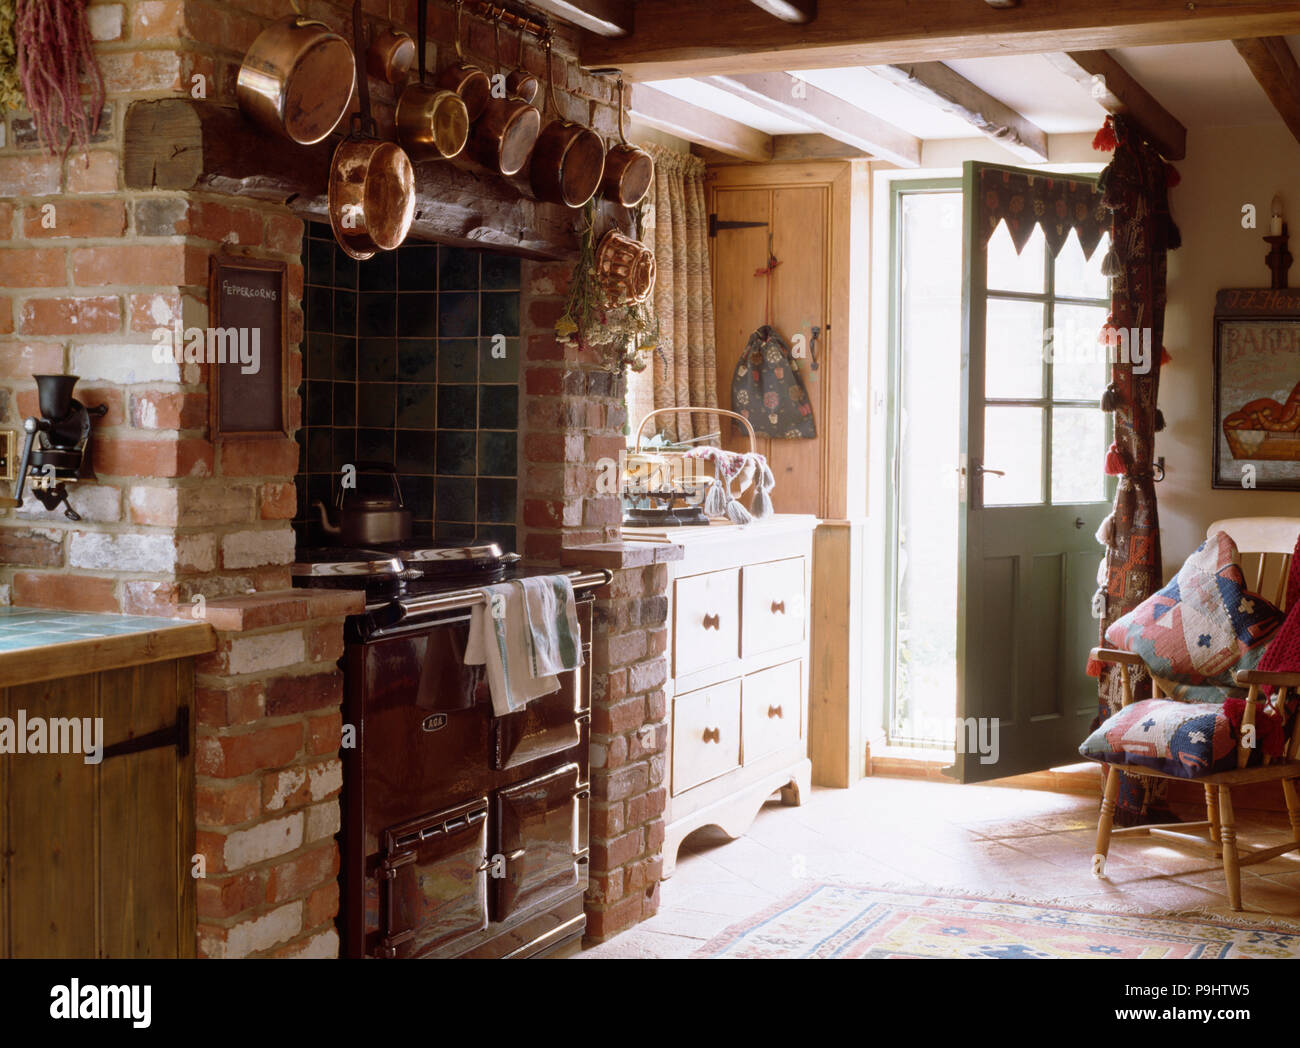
1088, 116, 1182, 826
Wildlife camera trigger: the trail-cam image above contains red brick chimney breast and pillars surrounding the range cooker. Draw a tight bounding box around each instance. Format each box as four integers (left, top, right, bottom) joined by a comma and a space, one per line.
0, 0, 655, 956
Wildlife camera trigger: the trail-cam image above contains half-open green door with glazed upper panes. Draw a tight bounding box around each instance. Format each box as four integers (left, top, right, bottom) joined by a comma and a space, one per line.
949, 163, 1113, 783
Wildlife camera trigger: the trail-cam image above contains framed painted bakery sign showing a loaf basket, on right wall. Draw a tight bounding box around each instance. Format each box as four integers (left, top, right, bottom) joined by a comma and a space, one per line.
1214, 289, 1300, 490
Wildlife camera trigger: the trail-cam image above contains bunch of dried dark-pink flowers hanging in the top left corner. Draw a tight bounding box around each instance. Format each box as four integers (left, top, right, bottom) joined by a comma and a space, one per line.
13, 0, 104, 156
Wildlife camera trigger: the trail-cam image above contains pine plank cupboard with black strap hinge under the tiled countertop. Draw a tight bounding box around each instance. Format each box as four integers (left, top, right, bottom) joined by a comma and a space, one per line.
0, 644, 211, 957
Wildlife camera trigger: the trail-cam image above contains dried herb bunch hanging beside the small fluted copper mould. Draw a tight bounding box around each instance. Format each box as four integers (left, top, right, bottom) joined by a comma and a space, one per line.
555, 200, 659, 372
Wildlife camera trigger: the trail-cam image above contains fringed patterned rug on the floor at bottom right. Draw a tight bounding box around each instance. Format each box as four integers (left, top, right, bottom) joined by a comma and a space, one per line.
694, 884, 1300, 960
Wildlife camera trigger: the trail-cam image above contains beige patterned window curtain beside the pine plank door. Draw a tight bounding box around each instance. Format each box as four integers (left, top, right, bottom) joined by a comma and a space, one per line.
628, 144, 722, 439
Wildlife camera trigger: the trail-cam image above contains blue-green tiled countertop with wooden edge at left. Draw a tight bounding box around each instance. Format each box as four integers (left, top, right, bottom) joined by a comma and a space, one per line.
0, 607, 215, 687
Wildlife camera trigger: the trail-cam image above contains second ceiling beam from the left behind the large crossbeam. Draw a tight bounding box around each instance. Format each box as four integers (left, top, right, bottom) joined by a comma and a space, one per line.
706, 73, 920, 168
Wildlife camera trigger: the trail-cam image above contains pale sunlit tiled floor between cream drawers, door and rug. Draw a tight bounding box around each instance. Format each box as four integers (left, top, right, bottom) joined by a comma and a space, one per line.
579, 778, 1300, 957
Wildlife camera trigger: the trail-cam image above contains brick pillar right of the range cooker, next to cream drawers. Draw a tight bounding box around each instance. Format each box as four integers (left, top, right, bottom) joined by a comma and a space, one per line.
520, 263, 683, 941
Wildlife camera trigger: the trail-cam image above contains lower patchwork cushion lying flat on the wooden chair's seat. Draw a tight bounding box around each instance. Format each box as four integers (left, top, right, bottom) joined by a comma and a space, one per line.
1079, 698, 1236, 779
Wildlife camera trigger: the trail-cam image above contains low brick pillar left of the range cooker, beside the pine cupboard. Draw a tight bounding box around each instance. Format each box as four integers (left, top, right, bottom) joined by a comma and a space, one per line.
195, 589, 363, 957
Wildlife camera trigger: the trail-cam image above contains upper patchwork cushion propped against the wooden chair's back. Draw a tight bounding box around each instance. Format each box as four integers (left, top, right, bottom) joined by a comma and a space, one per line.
1106, 532, 1283, 702
